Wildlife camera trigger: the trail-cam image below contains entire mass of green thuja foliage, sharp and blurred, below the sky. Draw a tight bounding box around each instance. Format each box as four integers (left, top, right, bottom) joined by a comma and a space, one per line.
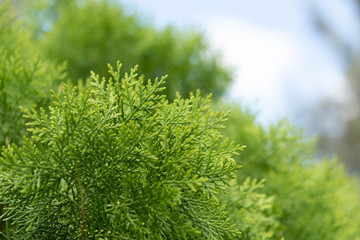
0, 0, 360, 240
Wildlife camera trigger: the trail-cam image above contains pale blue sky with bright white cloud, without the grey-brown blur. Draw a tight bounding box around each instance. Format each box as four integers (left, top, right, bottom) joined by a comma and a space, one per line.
121, 0, 359, 126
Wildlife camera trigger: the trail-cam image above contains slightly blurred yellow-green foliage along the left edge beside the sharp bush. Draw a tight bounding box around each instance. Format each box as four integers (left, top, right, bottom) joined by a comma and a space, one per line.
0, 3, 65, 146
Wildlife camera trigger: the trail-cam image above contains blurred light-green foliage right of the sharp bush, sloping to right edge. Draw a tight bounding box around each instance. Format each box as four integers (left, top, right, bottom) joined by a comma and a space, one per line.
224, 108, 360, 240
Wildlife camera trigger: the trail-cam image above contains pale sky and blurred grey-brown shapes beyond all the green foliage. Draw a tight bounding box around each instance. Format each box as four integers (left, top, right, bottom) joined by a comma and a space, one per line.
121, 0, 360, 170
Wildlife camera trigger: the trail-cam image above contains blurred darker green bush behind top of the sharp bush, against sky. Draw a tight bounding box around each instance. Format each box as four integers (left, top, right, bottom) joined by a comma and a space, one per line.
22, 0, 231, 99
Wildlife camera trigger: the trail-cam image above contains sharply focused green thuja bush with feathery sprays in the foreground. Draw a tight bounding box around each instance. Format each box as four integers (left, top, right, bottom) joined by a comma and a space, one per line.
0, 64, 241, 239
